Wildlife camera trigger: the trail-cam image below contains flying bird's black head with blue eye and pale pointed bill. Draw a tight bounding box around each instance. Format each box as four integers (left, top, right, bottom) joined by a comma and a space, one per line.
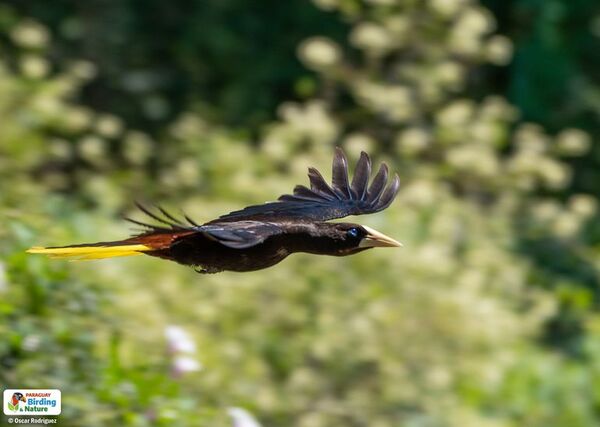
318, 222, 402, 256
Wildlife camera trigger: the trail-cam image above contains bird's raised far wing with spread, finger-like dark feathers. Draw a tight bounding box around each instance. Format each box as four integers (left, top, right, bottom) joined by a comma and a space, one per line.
209, 148, 400, 224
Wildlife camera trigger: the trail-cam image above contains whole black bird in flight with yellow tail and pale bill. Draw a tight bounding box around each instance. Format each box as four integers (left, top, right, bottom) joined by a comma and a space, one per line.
27, 148, 401, 273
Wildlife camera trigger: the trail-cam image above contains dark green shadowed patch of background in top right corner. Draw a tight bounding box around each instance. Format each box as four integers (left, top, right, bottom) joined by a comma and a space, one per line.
482, 0, 600, 193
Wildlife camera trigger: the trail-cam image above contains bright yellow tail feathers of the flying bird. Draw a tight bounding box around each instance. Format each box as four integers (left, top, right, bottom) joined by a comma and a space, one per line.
27, 245, 152, 261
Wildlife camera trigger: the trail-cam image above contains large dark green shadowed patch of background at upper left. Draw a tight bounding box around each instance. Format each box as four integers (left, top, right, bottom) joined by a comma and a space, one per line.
4, 0, 346, 133
